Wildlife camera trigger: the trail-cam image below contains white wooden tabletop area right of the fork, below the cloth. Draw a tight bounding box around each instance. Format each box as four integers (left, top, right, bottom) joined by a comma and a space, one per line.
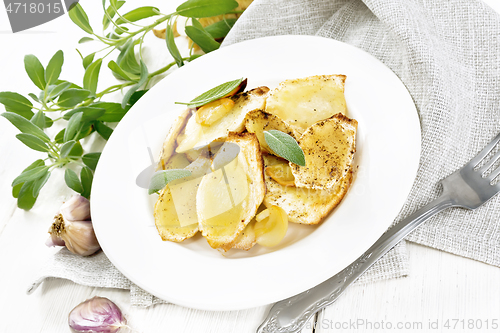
316, 243, 500, 333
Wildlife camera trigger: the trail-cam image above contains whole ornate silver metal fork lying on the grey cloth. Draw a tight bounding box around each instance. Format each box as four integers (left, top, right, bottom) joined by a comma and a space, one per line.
257, 134, 500, 333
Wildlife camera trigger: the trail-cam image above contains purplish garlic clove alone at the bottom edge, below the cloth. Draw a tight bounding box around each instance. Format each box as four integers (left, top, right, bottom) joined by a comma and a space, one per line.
68, 296, 127, 333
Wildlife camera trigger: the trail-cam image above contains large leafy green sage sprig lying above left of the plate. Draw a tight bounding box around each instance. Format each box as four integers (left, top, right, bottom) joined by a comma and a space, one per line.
0, 0, 246, 210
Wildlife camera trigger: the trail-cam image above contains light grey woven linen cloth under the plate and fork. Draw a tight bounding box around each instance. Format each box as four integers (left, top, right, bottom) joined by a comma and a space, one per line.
28, 0, 500, 306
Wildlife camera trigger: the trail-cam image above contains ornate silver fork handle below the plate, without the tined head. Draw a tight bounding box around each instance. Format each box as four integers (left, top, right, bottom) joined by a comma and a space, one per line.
257, 193, 454, 333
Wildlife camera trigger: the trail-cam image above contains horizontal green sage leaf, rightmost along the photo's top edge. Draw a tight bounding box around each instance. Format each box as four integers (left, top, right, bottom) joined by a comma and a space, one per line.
176, 0, 238, 18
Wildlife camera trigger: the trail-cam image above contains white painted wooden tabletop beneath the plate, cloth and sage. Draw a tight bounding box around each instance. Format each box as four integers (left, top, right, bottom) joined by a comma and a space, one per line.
0, 0, 500, 333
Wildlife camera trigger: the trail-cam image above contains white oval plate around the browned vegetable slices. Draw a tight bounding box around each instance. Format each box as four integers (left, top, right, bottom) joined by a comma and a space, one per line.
92, 36, 420, 310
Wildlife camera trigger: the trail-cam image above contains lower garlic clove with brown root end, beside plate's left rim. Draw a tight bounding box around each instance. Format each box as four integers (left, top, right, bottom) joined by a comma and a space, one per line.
49, 214, 101, 256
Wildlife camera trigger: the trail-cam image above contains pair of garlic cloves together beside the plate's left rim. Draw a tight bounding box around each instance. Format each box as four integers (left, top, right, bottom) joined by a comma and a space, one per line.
45, 195, 101, 256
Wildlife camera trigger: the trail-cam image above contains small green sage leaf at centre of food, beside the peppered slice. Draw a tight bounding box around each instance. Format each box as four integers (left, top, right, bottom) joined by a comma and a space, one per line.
264, 130, 306, 166
